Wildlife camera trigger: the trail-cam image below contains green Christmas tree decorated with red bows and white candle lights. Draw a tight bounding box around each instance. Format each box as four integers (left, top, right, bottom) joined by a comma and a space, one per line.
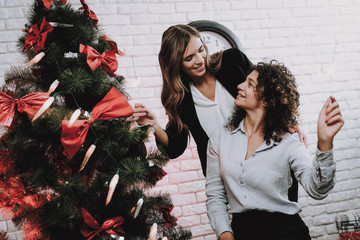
0, 0, 191, 239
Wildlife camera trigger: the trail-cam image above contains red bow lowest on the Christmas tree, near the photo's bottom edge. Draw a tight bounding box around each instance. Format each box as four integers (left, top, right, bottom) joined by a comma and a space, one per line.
81, 208, 125, 240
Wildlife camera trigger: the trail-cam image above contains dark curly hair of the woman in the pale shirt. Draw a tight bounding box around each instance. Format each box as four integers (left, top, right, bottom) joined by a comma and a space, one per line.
226, 60, 300, 144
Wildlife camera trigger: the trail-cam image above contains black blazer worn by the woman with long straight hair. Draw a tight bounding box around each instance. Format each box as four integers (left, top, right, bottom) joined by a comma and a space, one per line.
158, 48, 297, 200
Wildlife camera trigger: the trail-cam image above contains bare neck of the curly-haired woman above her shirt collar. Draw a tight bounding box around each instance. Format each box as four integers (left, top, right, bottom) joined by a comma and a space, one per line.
244, 110, 265, 137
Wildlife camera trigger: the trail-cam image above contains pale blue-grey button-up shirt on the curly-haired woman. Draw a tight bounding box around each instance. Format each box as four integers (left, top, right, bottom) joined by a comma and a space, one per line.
206, 121, 336, 237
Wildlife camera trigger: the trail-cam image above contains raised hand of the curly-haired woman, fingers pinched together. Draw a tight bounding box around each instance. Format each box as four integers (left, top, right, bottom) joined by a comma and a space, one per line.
317, 96, 344, 152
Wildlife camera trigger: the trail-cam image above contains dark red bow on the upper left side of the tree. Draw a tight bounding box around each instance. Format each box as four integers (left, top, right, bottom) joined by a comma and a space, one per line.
23, 18, 54, 52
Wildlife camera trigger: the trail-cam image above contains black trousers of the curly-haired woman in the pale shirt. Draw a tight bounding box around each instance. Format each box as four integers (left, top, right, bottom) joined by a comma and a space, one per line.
231, 210, 311, 240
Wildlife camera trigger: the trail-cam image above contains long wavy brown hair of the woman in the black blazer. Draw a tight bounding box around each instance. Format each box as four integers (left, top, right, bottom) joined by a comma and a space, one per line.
159, 24, 222, 132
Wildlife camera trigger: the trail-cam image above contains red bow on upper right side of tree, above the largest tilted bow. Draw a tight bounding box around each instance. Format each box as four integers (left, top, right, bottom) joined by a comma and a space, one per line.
79, 44, 118, 77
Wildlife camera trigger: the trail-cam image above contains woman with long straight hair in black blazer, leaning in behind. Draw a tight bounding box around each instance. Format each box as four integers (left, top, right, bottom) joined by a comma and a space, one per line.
134, 25, 250, 175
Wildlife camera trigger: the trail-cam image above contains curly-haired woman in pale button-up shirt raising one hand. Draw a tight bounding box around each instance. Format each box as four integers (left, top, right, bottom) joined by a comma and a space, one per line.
206, 60, 344, 240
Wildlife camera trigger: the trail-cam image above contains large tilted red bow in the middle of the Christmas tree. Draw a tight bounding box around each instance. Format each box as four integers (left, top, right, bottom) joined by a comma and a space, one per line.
61, 88, 133, 158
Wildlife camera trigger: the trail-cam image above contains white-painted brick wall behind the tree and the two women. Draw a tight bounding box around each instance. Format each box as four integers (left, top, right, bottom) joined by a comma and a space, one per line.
0, 0, 360, 240
